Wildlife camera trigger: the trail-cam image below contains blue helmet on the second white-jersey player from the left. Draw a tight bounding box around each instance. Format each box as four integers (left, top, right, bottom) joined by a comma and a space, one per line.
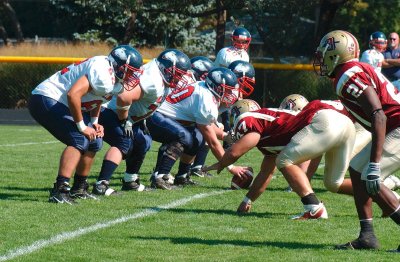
156, 49, 190, 88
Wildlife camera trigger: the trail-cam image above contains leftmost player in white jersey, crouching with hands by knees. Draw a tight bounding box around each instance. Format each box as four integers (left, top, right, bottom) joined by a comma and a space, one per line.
29, 46, 142, 204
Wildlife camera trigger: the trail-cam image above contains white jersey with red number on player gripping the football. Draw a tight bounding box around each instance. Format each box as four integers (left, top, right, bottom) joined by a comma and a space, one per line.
157, 81, 219, 125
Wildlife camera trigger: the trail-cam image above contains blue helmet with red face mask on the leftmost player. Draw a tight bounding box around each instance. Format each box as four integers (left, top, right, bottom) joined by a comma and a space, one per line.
108, 45, 143, 91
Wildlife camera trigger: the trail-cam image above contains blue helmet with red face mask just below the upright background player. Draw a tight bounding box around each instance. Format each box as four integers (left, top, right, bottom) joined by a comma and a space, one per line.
228, 60, 256, 97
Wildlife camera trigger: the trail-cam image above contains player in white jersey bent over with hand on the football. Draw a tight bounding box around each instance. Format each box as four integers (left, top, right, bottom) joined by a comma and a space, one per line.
147, 67, 245, 190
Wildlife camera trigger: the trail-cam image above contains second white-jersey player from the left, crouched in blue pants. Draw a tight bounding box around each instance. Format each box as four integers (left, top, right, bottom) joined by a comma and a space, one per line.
92, 49, 190, 195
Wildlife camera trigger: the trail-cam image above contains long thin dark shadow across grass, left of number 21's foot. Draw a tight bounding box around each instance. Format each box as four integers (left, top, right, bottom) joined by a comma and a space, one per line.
131, 236, 330, 249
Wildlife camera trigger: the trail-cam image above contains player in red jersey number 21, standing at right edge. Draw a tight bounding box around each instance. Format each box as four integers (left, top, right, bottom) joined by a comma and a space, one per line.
314, 30, 400, 251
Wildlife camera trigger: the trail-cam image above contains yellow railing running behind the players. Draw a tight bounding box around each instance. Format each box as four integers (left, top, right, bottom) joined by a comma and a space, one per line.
0, 56, 313, 70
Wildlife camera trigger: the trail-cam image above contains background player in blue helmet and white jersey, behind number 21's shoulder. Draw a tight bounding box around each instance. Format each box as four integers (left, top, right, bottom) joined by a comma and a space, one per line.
360, 31, 387, 72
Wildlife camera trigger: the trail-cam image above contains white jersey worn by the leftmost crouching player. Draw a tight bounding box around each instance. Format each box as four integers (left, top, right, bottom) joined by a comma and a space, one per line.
32, 56, 123, 111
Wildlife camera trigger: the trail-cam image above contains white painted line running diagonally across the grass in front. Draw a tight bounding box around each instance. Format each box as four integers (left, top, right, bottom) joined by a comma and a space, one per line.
0, 190, 231, 261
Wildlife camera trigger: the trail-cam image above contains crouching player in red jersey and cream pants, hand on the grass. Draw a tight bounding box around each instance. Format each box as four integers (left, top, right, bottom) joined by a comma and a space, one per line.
207, 100, 355, 219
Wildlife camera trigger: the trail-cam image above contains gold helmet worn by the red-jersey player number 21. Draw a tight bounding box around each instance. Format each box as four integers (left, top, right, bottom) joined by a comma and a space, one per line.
313, 30, 360, 76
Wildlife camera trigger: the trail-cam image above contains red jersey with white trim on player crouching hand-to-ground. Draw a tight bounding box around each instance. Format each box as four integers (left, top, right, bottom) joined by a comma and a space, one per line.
233, 100, 348, 155
